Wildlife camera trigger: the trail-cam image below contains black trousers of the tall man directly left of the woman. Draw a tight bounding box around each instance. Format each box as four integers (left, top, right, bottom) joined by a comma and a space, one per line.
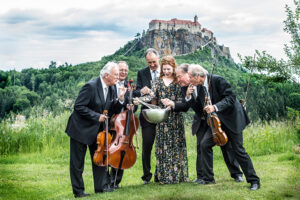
142, 125, 156, 181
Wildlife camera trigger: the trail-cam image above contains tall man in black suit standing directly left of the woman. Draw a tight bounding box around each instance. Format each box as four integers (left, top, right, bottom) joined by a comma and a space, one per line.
135, 48, 160, 184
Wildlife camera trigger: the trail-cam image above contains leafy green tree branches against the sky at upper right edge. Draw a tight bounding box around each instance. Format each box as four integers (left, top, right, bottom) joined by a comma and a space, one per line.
238, 0, 300, 82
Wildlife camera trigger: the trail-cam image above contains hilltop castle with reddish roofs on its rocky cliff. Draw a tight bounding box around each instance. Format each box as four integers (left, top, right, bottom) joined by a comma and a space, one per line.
137, 15, 232, 59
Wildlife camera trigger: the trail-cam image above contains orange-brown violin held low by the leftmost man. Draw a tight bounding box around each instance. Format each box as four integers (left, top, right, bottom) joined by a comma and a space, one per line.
93, 110, 111, 170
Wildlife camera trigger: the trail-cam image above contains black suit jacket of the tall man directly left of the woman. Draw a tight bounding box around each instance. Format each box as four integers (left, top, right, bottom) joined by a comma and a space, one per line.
134, 67, 155, 127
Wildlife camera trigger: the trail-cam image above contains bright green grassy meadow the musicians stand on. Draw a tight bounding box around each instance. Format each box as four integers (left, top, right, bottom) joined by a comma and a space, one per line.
0, 115, 300, 200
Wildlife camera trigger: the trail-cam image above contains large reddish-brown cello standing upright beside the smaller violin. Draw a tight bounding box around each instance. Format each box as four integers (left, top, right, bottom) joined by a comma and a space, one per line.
109, 79, 139, 169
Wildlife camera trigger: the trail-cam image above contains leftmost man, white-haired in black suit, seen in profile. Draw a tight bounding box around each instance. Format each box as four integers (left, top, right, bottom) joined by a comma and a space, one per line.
66, 62, 126, 197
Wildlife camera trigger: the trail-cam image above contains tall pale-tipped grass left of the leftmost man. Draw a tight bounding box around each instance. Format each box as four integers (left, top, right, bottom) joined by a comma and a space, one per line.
0, 112, 70, 155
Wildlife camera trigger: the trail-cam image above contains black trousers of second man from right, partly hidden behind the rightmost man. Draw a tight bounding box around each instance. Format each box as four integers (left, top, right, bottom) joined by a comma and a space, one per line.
196, 123, 243, 179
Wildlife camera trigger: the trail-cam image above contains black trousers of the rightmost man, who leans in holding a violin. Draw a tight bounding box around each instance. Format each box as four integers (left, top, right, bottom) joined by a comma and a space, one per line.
201, 127, 259, 182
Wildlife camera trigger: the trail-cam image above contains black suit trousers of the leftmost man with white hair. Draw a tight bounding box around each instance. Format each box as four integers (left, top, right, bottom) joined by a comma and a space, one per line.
70, 138, 107, 194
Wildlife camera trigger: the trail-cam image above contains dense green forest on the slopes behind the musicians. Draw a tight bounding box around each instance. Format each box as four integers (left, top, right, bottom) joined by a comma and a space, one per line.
0, 47, 300, 121
